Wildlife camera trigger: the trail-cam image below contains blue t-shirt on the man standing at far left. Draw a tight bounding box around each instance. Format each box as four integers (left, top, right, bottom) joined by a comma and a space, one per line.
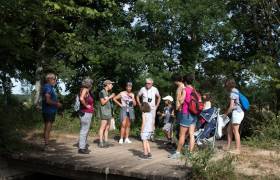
42, 84, 57, 113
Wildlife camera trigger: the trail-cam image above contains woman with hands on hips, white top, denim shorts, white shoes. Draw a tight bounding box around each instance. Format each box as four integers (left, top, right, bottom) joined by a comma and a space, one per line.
113, 82, 136, 144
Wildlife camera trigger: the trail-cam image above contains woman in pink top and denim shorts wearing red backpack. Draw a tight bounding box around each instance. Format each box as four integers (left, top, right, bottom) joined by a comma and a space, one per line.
169, 74, 202, 159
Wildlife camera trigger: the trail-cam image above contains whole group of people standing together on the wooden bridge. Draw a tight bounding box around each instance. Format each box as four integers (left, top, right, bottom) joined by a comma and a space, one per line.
42, 73, 244, 159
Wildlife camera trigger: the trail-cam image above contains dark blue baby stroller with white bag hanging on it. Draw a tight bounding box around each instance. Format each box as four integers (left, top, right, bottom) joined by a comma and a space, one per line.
195, 107, 229, 148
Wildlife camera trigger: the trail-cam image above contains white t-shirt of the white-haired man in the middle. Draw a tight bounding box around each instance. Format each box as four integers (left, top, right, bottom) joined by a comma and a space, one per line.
138, 86, 159, 109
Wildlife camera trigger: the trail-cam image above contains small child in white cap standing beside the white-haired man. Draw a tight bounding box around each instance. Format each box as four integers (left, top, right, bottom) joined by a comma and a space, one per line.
158, 96, 174, 144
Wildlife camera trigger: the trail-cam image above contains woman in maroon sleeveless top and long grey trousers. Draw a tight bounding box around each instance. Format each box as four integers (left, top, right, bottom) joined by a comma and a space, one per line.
78, 78, 94, 154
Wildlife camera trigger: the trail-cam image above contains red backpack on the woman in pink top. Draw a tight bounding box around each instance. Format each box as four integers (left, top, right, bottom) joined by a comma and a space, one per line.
189, 89, 204, 115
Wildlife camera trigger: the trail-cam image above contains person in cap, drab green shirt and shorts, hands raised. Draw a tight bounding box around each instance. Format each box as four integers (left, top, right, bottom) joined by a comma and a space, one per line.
99, 80, 115, 148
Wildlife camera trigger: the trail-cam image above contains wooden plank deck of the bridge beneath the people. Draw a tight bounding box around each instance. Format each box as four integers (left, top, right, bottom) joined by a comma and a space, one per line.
2, 138, 188, 180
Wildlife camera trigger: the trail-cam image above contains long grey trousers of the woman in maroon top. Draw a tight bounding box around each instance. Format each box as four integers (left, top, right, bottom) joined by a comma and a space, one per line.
79, 113, 92, 149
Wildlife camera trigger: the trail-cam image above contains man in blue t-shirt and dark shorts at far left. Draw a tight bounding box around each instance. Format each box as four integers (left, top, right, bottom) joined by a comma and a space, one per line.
42, 73, 62, 150
